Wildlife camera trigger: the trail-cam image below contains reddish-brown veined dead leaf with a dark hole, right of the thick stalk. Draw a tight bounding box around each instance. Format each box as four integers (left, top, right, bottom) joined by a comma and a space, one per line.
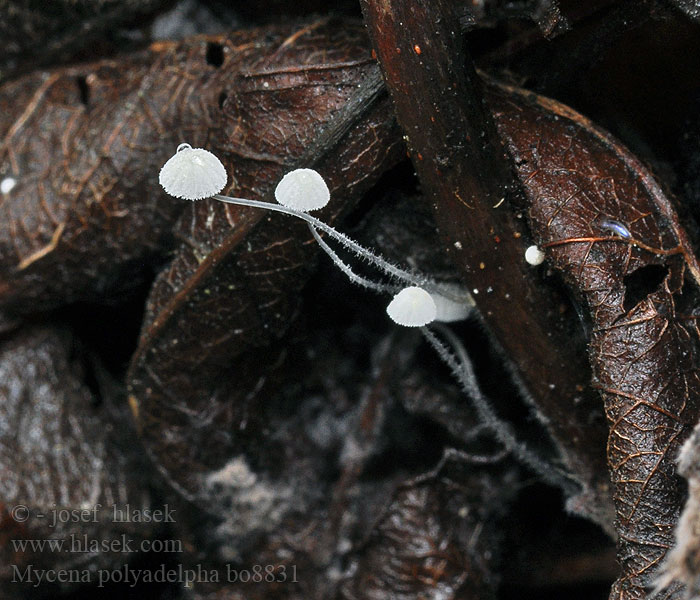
488, 79, 700, 599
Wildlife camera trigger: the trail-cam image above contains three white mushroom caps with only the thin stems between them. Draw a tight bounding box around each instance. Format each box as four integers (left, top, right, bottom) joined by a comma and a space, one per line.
159, 144, 474, 327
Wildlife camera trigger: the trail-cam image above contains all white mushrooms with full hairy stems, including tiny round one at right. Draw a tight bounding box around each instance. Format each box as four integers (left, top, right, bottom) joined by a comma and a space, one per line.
159, 144, 564, 487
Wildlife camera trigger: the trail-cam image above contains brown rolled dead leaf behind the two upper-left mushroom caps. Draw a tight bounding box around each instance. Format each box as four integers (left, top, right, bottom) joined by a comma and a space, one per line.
0, 19, 386, 312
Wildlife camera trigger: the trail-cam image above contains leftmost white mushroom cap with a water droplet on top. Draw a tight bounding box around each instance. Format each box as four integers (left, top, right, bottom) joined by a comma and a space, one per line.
158, 144, 228, 200
